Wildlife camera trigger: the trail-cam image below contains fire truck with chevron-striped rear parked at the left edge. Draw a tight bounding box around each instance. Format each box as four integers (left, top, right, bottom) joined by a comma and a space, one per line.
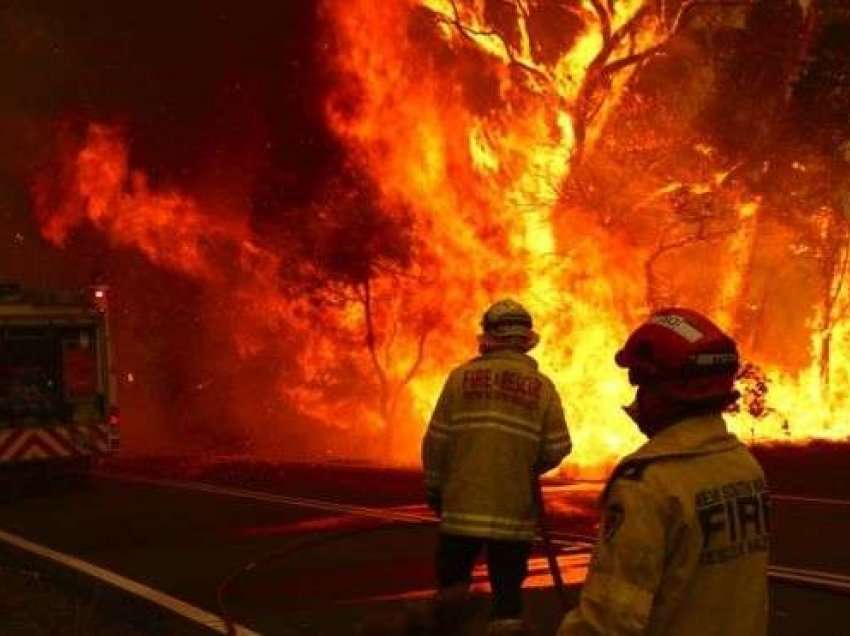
0, 283, 119, 473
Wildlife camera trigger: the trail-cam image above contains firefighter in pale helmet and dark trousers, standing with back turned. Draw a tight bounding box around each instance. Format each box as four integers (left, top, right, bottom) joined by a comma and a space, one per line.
422, 300, 571, 634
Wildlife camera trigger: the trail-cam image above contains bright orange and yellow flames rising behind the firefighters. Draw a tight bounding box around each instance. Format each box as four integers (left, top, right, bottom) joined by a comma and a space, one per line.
36, 0, 850, 474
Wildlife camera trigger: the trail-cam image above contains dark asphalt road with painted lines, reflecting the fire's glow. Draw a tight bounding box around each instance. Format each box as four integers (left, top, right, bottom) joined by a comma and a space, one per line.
0, 461, 850, 636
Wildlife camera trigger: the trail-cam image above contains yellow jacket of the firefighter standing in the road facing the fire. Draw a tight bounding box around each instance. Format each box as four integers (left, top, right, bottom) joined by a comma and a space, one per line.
422, 351, 571, 541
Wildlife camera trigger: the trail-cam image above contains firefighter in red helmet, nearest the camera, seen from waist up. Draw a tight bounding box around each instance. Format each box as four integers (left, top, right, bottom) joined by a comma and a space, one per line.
558, 308, 769, 636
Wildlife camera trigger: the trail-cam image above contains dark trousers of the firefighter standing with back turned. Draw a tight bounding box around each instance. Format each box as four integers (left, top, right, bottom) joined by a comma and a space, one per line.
437, 532, 531, 619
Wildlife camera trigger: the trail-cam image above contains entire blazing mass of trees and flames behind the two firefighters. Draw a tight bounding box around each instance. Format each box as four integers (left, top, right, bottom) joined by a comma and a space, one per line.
24, 0, 850, 466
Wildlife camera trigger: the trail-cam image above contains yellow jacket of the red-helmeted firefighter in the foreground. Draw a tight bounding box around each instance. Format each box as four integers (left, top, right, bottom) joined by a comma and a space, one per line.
558, 415, 769, 636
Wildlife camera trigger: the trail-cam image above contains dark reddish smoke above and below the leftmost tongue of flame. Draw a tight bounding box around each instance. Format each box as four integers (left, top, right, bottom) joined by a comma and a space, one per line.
0, 0, 372, 450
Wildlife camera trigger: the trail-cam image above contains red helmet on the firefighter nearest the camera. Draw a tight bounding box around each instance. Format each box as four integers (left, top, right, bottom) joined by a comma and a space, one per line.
614, 307, 739, 402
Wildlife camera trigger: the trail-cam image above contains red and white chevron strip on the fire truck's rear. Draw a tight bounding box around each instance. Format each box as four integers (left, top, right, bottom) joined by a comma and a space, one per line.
0, 423, 110, 462
